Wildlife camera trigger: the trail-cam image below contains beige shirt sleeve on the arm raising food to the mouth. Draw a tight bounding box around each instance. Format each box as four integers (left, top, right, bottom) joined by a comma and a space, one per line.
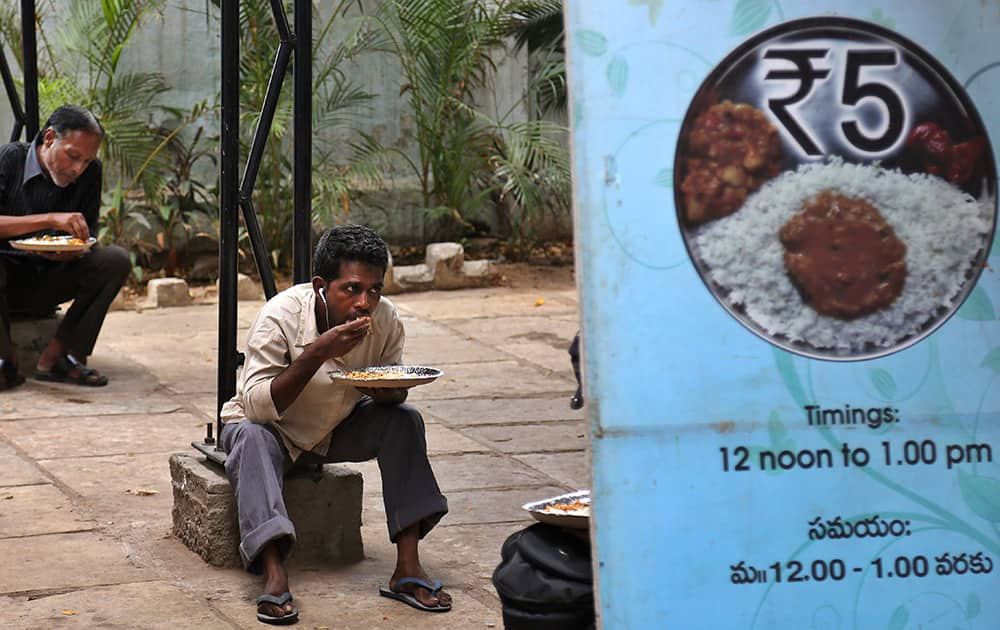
243, 320, 290, 424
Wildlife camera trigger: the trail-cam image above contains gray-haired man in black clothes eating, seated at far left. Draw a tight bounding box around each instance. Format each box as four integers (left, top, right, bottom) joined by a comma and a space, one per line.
0, 105, 131, 389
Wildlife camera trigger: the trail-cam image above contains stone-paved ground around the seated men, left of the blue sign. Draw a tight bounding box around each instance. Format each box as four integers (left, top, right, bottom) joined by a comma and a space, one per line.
0, 285, 589, 630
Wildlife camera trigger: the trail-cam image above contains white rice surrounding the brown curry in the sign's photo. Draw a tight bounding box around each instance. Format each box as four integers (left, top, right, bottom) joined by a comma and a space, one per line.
689, 159, 993, 354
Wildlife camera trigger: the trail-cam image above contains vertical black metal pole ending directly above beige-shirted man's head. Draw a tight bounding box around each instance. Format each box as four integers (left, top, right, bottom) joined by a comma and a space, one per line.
292, 0, 312, 283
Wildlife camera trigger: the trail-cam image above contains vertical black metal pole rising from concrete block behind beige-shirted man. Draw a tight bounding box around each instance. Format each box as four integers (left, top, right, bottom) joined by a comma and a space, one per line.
216, 0, 240, 446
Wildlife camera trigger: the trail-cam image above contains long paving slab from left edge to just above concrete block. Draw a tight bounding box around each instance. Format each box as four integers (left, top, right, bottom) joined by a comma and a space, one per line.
0, 413, 204, 465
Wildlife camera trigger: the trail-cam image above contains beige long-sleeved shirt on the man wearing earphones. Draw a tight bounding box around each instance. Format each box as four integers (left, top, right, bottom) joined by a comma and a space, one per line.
221, 284, 405, 460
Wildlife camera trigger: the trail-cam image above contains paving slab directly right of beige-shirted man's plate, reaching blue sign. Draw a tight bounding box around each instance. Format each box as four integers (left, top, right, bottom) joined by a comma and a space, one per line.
409, 361, 576, 401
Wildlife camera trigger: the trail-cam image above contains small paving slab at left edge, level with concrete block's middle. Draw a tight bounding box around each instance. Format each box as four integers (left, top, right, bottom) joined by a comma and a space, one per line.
0, 484, 97, 538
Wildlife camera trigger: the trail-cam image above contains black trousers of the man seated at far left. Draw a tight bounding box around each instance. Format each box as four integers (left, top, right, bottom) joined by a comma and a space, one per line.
0, 246, 131, 360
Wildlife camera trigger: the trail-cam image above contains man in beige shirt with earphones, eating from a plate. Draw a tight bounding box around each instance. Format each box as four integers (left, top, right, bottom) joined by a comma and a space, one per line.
219, 225, 451, 624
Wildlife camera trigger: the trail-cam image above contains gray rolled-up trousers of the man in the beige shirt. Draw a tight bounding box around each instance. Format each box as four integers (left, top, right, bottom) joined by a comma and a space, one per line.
225, 397, 448, 572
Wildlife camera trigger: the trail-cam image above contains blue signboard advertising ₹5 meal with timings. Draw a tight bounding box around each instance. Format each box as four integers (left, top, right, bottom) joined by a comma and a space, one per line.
566, 0, 1000, 630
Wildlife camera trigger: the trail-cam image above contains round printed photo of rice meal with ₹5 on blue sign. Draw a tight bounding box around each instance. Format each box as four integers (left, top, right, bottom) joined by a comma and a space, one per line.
674, 17, 996, 360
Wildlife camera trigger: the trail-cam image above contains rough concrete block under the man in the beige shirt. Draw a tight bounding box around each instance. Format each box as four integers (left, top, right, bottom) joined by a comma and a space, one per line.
170, 452, 364, 567
